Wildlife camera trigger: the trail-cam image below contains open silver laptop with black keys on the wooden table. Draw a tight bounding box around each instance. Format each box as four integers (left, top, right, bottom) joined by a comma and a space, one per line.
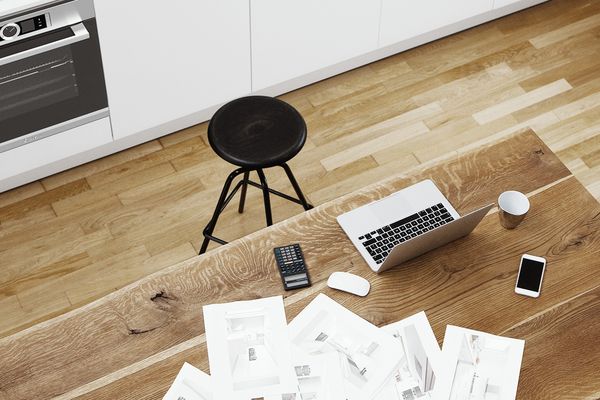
337, 179, 493, 273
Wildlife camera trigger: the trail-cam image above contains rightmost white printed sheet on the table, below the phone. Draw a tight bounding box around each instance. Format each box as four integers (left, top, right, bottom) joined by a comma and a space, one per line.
438, 325, 525, 400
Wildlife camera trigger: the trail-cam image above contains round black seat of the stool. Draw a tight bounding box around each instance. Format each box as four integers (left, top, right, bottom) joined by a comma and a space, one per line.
208, 96, 306, 169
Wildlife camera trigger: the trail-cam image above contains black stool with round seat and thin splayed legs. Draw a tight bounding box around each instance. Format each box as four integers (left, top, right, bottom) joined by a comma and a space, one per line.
199, 96, 313, 254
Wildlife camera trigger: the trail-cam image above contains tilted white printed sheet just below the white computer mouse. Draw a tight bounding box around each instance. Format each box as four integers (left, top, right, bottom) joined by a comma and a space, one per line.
289, 294, 402, 400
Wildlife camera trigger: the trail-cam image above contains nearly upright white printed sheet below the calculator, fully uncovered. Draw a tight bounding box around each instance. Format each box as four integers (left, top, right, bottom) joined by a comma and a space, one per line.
203, 296, 298, 400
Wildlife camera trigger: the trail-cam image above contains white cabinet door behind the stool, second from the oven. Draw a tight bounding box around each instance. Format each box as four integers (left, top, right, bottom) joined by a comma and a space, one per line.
251, 0, 381, 90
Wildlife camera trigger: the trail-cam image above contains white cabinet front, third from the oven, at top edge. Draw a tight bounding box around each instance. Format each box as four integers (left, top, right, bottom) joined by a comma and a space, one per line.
379, 0, 497, 47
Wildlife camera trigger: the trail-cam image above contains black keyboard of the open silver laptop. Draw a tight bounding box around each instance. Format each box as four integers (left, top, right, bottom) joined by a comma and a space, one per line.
358, 203, 454, 264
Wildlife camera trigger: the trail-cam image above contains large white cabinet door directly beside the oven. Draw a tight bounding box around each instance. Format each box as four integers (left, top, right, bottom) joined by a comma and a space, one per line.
95, 0, 251, 139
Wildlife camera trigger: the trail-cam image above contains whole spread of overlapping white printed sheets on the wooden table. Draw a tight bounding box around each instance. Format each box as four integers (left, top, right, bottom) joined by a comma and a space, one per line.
164, 294, 524, 400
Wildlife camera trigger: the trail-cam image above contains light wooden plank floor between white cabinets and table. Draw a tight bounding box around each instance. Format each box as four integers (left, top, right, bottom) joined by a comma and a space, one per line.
0, 0, 600, 336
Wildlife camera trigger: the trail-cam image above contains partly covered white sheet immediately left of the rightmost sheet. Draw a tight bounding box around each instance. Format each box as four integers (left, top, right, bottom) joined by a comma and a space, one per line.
376, 311, 442, 400
